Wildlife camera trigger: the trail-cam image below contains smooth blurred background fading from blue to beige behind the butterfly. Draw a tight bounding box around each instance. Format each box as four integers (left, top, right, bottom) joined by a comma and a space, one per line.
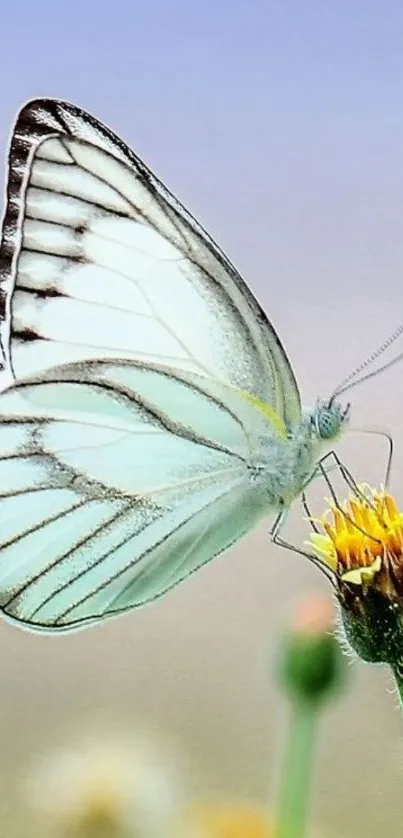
0, 0, 403, 838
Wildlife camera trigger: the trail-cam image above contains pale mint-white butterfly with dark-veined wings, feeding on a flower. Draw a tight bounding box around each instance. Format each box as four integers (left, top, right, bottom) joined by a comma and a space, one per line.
0, 99, 348, 632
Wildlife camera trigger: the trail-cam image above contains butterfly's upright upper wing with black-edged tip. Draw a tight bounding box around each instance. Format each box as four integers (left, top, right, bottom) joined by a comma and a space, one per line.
0, 99, 300, 424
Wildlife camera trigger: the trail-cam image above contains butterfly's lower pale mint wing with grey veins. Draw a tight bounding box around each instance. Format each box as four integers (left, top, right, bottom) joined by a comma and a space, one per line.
0, 361, 276, 631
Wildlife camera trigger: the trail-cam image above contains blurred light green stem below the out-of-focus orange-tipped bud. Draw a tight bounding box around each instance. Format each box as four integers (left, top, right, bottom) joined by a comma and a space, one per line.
277, 700, 319, 838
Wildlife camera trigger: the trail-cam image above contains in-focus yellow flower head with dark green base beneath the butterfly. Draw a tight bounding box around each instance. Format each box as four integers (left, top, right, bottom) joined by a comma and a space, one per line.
310, 486, 403, 675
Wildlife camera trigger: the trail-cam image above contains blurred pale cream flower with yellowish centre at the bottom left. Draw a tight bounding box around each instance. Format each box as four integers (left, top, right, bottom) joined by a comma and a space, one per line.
23, 735, 182, 838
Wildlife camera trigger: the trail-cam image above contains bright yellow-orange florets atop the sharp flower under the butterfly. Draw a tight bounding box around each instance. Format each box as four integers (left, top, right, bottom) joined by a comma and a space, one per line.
310, 486, 403, 594
